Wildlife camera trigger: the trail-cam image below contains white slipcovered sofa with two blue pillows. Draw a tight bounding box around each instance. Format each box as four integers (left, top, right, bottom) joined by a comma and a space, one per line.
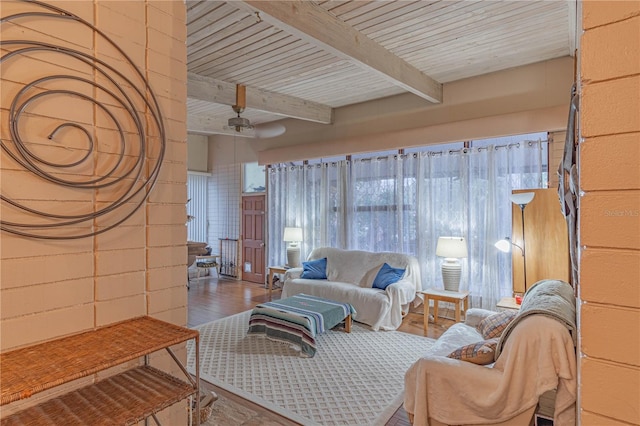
282, 247, 422, 331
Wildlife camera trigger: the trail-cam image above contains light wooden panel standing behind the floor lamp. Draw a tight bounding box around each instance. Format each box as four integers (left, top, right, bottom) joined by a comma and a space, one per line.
511, 188, 570, 293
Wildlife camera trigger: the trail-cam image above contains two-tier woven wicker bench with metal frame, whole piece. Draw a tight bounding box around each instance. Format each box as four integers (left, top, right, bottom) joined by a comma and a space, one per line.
0, 317, 200, 426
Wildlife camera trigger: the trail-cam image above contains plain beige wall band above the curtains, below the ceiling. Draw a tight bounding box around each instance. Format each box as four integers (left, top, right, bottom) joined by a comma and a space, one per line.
236, 57, 574, 164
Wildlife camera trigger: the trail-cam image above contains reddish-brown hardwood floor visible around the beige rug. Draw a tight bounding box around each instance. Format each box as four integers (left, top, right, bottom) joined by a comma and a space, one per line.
188, 277, 453, 426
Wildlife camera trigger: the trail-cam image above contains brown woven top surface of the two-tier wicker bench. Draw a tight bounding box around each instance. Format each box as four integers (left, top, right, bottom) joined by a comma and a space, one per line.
0, 317, 199, 405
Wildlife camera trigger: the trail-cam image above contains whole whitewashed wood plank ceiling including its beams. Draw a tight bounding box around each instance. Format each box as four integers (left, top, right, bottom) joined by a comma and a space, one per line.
186, 0, 575, 136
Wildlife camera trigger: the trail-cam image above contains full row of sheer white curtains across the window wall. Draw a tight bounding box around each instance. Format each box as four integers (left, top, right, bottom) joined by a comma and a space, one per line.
268, 142, 546, 308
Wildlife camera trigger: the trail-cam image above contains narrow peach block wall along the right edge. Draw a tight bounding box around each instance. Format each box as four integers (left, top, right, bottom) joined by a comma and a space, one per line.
579, 0, 640, 426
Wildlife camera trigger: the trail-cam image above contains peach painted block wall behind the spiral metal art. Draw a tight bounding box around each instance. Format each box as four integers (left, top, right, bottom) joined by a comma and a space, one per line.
0, 0, 187, 425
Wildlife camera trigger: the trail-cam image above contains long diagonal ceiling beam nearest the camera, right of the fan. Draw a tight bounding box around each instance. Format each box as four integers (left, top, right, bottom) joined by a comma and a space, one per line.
234, 0, 442, 103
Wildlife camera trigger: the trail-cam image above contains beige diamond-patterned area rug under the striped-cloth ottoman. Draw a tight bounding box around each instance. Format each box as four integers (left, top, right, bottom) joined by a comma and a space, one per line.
187, 311, 434, 426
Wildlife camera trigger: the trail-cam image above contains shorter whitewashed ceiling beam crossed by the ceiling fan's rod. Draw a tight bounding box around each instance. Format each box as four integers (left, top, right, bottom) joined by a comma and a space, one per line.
187, 73, 333, 124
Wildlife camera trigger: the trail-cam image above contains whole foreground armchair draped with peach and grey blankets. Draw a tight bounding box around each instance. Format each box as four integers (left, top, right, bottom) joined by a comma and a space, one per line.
404, 280, 577, 426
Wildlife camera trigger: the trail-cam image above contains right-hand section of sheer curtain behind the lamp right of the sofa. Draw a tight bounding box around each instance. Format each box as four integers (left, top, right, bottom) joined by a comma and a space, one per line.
417, 142, 544, 309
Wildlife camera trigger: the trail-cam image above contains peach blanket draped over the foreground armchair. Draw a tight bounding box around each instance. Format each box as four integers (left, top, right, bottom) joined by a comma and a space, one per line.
404, 315, 577, 426
